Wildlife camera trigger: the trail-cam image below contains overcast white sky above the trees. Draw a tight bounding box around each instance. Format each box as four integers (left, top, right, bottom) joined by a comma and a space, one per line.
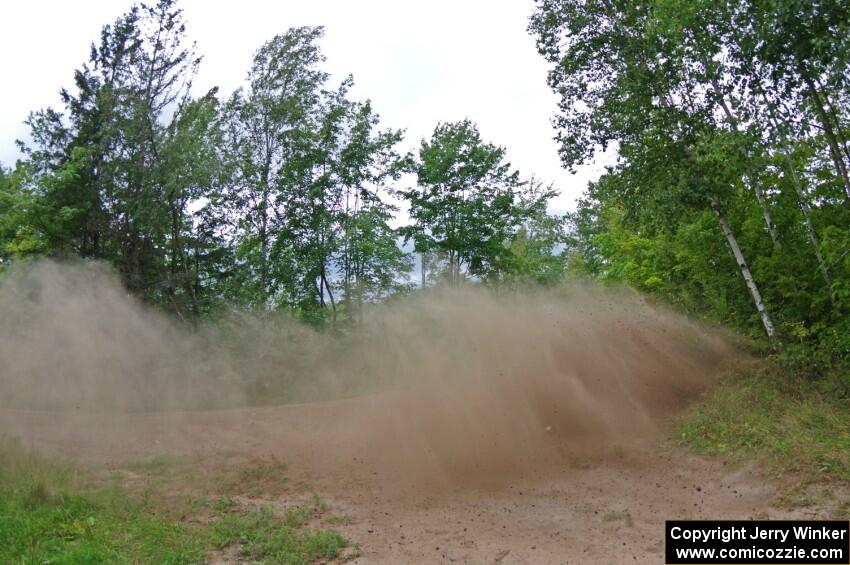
0, 0, 602, 211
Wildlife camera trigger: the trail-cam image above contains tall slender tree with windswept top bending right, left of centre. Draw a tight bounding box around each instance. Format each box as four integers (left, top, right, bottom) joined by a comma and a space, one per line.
219, 27, 328, 304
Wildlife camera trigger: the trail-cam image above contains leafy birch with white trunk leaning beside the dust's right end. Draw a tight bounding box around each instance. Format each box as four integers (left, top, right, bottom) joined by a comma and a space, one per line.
530, 0, 775, 339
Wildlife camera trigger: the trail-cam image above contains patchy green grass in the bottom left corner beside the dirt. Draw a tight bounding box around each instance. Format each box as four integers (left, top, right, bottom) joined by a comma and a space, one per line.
0, 439, 348, 564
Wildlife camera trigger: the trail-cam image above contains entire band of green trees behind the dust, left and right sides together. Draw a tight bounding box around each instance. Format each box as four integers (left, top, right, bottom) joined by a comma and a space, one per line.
0, 0, 850, 365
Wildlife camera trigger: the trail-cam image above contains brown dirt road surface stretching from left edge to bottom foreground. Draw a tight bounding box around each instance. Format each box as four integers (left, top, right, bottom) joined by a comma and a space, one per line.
0, 396, 817, 564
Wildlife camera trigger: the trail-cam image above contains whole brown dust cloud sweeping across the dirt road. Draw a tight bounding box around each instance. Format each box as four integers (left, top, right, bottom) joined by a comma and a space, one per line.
0, 262, 736, 483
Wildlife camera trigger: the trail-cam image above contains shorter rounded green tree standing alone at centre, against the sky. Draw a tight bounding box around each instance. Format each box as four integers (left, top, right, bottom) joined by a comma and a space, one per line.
401, 120, 561, 284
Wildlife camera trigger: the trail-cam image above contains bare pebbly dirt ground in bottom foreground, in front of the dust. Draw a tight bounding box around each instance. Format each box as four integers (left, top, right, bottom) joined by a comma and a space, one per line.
326, 449, 811, 565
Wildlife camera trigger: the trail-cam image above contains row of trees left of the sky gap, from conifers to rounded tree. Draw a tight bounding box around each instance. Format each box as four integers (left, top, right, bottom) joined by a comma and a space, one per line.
0, 0, 564, 322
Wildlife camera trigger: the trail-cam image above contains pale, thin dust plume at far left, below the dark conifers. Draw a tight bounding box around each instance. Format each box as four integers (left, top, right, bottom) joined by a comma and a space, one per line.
0, 261, 248, 411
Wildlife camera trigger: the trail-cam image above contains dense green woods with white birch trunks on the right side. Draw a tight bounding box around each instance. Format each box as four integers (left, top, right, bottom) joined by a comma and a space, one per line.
530, 0, 850, 363
